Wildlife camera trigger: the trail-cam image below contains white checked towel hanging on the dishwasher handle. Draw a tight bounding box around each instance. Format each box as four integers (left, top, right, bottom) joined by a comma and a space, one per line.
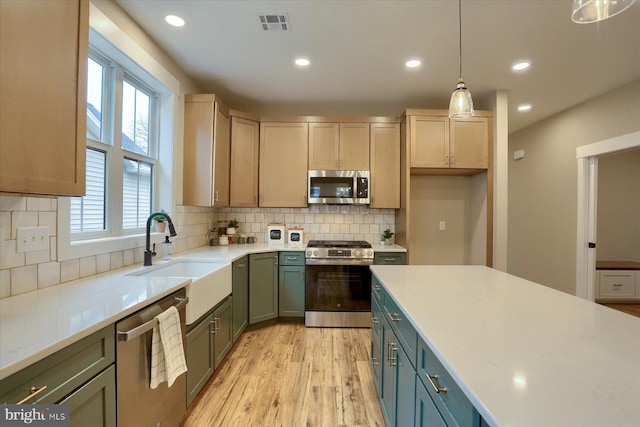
150, 307, 187, 388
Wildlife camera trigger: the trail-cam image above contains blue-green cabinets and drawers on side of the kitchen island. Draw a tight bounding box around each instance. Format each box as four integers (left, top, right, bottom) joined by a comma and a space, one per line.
371, 276, 486, 427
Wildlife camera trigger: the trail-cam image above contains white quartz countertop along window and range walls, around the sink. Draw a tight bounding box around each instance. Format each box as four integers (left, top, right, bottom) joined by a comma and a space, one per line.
0, 243, 405, 379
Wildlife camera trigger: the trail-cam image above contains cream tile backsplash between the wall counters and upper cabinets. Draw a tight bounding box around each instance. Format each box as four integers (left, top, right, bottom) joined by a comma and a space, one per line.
0, 194, 395, 298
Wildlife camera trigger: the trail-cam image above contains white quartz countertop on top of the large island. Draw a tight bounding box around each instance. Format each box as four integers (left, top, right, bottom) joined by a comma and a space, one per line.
371, 266, 640, 427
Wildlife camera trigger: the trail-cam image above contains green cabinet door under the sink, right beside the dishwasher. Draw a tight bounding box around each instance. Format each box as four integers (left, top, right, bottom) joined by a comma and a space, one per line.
186, 315, 215, 406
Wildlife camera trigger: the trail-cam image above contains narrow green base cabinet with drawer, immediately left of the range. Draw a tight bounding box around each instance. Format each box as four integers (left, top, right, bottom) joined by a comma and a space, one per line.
278, 251, 305, 317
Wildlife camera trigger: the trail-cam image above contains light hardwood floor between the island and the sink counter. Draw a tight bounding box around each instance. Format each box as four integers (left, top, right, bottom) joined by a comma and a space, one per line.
182, 322, 385, 427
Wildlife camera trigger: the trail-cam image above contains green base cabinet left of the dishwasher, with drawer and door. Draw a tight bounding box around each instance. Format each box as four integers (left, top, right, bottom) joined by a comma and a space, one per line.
0, 325, 116, 427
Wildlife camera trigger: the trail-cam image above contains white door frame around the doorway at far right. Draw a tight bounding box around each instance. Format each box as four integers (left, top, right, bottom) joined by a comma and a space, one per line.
576, 131, 640, 301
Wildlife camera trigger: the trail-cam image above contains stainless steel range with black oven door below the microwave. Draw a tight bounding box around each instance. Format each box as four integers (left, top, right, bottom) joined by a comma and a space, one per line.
304, 240, 373, 327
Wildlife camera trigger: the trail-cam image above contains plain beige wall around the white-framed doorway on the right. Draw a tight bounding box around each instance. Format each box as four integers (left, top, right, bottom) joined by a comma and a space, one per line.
507, 80, 640, 294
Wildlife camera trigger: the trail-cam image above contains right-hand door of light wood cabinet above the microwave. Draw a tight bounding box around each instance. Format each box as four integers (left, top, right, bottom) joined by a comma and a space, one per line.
338, 123, 370, 171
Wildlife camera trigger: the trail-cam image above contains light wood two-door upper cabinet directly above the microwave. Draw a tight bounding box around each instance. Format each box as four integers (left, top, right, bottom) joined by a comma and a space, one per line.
309, 123, 369, 170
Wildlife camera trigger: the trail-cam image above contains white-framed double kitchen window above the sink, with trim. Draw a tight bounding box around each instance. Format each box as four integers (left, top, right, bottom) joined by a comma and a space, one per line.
58, 28, 179, 261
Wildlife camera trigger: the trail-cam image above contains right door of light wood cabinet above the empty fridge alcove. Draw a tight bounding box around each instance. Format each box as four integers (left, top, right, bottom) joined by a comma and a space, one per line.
449, 117, 489, 169
